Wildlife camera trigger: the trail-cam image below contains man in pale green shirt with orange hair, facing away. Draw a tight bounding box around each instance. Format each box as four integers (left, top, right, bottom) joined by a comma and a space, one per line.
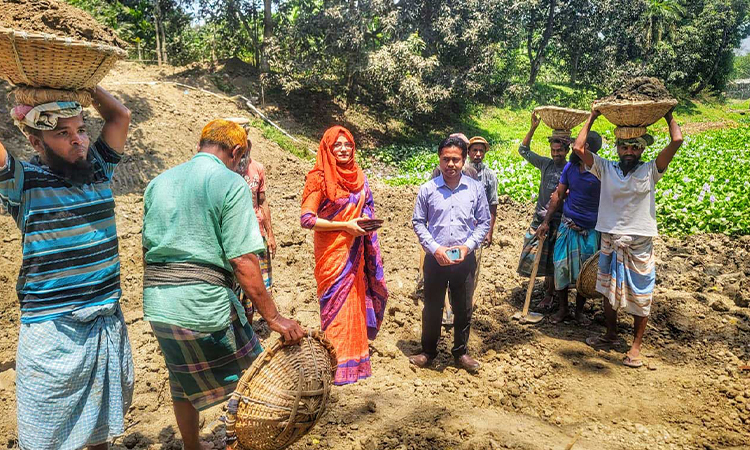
143, 120, 305, 450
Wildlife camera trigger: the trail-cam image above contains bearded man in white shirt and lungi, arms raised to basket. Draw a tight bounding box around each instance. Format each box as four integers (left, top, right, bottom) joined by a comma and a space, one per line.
573, 110, 682, 367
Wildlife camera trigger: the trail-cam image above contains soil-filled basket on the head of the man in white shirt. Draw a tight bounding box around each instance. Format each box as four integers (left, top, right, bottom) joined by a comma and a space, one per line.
593, 77, 677, 139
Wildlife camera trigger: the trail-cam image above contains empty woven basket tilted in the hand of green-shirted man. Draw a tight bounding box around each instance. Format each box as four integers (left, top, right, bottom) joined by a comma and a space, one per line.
226, 332, 337, 450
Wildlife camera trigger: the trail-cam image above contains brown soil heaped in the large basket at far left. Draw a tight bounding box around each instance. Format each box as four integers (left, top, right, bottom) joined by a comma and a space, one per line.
0, 0, 128, 49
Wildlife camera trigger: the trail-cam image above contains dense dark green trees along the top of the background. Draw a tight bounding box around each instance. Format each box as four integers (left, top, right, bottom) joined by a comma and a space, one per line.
67, 0, 750, 123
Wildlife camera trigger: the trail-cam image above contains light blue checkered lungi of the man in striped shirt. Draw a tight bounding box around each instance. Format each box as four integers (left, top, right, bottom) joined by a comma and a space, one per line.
16, 303, 134, 450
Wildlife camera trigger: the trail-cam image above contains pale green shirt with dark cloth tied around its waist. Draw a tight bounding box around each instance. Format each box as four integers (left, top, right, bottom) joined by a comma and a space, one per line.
143, 153, 265, 332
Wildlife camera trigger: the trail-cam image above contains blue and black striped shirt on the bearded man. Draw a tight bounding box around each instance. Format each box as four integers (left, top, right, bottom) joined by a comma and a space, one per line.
0, 138, 121, 323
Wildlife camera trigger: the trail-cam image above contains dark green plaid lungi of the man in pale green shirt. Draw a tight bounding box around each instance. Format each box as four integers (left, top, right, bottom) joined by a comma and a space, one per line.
150, 310, 263, 411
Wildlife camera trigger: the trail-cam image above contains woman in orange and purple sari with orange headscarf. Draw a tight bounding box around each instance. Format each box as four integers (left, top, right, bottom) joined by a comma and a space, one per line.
300, 126, 388, 385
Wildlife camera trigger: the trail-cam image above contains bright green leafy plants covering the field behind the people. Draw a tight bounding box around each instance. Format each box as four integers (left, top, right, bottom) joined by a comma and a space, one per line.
369, 102, 750, 235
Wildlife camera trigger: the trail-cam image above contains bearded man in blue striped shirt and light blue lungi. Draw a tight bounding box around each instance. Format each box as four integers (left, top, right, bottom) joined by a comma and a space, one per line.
0, 88, 133, 449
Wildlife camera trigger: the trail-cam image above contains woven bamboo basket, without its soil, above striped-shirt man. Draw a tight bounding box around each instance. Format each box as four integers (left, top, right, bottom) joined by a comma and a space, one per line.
0, 28, 127, 90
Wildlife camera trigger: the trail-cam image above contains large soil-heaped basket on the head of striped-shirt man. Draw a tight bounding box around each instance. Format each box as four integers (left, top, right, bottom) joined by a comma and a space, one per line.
0, 0, 127, 90
